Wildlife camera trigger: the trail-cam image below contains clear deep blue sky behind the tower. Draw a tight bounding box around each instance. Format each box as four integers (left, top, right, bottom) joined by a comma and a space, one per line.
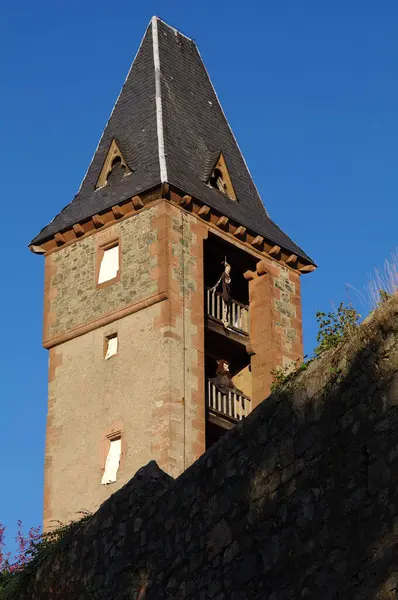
0, 0, 398, 552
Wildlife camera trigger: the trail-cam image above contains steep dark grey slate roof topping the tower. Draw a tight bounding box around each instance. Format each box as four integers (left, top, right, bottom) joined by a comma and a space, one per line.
31, 17, 313, 262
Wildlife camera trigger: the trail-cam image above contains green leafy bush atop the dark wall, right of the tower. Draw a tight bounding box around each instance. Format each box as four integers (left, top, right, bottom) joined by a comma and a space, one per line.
314, 302, 361, 356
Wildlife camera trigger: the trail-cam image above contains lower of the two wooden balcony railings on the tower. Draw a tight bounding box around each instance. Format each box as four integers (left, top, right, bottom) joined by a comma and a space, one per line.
206, 379, 252, 429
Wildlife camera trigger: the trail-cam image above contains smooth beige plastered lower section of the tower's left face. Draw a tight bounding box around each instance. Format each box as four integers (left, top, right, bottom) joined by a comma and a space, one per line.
44, 304, 170, 526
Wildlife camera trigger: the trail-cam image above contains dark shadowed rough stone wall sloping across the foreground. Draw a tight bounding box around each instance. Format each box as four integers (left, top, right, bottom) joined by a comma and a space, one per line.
21, 299, 398, 600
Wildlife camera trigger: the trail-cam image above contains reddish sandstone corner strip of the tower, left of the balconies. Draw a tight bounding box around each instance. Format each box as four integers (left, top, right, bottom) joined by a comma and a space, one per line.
151, 203, 207, 477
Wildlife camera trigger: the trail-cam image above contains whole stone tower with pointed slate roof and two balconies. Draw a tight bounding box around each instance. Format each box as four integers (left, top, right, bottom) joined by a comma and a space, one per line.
30, 17, 315, 528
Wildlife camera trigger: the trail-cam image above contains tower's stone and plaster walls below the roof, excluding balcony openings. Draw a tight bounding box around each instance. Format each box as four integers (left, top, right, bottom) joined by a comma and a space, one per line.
44, 200, 302, 527
